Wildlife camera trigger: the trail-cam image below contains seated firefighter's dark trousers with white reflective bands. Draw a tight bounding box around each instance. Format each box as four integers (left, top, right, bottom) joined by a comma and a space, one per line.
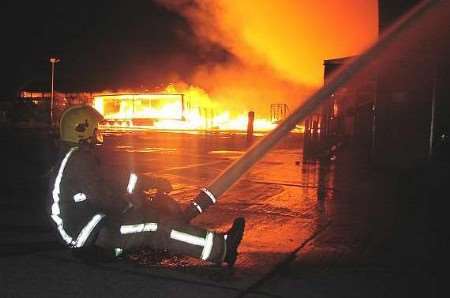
95, 205, 226, 263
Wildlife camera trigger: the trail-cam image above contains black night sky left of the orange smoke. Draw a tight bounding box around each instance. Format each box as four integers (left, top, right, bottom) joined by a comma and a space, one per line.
0, 0, 229, 98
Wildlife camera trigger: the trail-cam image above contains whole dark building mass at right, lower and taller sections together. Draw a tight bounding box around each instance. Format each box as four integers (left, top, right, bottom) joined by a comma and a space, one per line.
305, 1, 450, 167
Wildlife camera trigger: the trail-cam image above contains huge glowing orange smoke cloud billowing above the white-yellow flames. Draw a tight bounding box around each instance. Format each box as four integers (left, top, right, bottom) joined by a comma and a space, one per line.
155, 0, 378, 117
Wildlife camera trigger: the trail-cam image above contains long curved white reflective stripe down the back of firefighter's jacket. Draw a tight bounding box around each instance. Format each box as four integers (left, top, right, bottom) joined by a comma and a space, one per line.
51, 147, 78, 245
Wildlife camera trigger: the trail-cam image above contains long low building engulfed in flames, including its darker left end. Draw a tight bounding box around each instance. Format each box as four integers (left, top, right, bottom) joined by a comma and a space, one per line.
20, 85, 284, 132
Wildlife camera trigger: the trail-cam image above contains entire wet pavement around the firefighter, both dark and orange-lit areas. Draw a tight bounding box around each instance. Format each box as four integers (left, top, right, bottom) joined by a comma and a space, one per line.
0, 131, 442, 297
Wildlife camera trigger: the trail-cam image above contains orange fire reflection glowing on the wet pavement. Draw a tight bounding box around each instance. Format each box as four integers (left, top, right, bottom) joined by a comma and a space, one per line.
103, 133, 334, 275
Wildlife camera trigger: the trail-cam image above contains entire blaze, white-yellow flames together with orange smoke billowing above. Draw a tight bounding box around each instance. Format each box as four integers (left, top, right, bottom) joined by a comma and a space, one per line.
94, 0, 377, 132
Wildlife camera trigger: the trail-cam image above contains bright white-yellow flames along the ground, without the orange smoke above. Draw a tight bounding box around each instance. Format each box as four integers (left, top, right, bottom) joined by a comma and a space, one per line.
93, 85, 276, 132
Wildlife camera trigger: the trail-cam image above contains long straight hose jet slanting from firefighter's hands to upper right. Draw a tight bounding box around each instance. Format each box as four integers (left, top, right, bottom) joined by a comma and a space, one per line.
183, 0, 440, 222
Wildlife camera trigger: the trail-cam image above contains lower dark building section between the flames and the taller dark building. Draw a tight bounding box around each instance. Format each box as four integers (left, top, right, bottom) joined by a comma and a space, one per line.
304, 57, 376, 158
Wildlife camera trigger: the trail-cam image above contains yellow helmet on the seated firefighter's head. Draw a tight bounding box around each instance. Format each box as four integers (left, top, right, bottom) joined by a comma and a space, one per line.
59, 105, 103, 144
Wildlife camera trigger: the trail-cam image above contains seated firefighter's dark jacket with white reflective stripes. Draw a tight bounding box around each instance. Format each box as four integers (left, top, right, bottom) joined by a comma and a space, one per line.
50, 145, 158, 247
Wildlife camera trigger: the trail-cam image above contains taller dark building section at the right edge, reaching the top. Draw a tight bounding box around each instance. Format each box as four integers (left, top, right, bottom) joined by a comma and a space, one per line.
372, 0, 450, 166
